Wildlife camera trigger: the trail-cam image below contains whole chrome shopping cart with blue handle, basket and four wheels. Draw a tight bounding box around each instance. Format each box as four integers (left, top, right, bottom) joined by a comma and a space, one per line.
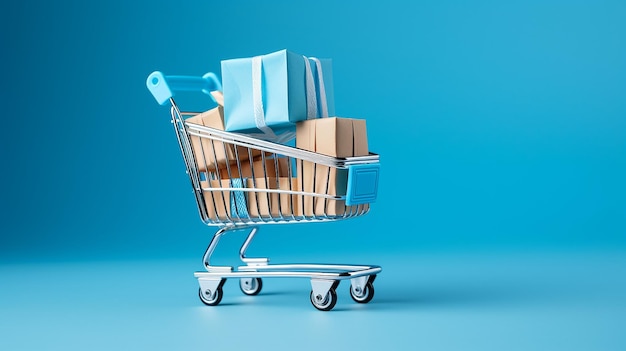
147, 72, 382, 311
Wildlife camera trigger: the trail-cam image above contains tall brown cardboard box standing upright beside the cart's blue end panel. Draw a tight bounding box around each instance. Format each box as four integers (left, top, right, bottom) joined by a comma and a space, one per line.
296, 117, 369, 216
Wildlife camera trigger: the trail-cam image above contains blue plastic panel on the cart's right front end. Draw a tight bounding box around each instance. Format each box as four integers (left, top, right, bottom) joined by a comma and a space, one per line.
346, 163, 380, 206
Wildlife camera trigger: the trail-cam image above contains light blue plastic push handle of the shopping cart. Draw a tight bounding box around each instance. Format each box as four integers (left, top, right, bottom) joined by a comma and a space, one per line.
146, 71, 222, 105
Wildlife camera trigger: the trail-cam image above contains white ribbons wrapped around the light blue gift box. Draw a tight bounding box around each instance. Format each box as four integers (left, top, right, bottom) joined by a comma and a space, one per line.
250, 56, 328, 143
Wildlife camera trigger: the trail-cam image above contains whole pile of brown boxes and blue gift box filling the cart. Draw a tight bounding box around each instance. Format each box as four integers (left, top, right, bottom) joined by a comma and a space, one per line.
187, 50, 369, 221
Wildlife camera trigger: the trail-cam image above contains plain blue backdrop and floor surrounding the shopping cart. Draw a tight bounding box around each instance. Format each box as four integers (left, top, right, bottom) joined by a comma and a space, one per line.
0, 0, 626, 349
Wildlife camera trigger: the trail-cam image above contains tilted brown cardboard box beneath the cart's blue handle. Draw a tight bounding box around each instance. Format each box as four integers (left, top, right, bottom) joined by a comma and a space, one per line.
186, 92, 261, 172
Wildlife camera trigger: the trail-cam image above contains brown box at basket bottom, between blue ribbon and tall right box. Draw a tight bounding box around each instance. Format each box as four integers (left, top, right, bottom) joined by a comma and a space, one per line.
246, 177, 299, 219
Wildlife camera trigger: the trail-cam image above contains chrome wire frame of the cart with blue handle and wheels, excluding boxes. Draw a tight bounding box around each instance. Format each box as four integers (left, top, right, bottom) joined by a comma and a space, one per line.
147, 72, 382, 311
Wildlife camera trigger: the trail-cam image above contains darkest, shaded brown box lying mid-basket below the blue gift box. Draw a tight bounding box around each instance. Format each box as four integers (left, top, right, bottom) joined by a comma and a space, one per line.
218, 156, 289, 179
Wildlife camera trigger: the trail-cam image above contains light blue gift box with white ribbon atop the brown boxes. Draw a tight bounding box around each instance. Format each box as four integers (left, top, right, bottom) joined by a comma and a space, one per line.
222, 50, 335, 140
